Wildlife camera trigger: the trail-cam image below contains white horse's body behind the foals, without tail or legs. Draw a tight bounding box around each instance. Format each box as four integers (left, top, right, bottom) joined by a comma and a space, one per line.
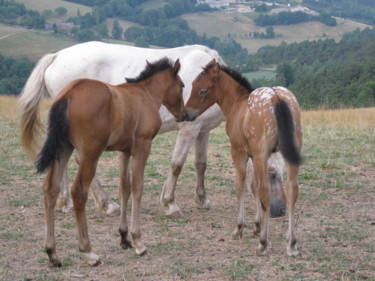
44, 42, 224, 132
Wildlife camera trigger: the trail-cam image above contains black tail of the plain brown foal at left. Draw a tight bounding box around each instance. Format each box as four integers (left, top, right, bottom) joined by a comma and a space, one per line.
35, 99, 69, 173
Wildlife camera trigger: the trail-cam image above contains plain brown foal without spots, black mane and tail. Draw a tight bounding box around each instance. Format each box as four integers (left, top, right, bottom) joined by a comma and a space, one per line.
36, 58, 184, 266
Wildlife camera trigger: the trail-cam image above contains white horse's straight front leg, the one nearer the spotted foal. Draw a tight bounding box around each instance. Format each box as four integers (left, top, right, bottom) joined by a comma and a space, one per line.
195, 131, 211, 209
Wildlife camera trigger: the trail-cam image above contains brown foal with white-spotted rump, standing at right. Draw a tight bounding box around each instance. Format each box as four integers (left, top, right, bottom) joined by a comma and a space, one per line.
185, 60, 302, 255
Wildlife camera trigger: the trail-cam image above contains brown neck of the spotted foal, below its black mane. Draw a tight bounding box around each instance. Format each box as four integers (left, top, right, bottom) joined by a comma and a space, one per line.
217, 73, 248, 117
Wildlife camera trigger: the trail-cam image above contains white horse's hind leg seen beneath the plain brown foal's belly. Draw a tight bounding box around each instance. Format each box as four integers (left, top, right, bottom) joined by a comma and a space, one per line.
76, 154, 120, 216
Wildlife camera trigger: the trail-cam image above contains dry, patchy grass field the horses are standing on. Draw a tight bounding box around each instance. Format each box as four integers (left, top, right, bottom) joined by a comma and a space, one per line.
0, 96, 375, 281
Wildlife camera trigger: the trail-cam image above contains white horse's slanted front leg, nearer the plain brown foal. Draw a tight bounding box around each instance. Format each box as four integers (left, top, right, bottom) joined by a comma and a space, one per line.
160, 123, 200, 216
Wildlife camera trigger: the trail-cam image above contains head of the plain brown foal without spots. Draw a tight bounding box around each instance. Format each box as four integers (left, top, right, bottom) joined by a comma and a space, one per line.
162, 59, 186, 122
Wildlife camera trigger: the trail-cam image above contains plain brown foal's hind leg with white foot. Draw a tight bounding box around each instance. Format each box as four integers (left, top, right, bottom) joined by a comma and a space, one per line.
71, 153, 100, 266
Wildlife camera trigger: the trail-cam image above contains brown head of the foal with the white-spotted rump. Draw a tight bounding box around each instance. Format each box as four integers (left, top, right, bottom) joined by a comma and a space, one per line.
184, 59, 221, 121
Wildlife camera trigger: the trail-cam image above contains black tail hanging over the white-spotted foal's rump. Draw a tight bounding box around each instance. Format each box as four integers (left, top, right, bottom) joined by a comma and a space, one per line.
275, 100, 302, 165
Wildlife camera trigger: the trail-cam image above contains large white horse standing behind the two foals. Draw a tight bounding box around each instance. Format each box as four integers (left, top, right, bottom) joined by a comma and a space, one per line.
19, 42, 286, 216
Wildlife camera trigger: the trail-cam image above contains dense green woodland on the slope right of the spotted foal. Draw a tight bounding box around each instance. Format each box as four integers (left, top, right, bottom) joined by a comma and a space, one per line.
248, 28, 375, 108
